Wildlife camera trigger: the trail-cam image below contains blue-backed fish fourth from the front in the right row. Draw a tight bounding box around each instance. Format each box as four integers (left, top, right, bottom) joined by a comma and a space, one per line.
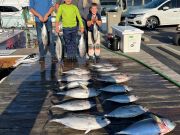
99, 84, 132, 93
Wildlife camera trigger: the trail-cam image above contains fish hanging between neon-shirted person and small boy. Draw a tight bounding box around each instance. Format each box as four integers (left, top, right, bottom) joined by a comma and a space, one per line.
78, 34, 86, 58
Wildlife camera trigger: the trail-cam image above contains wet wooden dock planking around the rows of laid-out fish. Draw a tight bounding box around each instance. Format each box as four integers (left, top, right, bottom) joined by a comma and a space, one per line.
0, 49, 180, 135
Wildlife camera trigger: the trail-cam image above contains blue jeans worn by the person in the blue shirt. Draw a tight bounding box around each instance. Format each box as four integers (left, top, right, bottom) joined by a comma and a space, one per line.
36, 21, 56, 57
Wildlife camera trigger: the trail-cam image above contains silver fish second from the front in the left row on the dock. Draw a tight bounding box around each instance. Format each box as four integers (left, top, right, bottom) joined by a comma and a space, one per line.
52, 100, 96, 111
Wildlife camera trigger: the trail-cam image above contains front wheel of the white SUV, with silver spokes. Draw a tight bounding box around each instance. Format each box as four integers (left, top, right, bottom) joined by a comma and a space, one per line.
146, 16, 159, 30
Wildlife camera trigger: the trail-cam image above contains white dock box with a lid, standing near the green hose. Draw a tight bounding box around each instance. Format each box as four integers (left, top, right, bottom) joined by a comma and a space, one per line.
112, 26, 144, 53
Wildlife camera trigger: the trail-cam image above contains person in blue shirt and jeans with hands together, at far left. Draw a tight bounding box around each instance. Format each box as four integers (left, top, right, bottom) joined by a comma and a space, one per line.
30, 0, 57, 62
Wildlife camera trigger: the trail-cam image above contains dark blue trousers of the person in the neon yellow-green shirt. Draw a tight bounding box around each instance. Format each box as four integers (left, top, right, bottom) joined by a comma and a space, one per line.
63, 27, 78, 58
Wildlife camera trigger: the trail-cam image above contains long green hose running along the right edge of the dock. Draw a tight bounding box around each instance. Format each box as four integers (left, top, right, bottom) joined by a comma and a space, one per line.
102, 46, 180, 88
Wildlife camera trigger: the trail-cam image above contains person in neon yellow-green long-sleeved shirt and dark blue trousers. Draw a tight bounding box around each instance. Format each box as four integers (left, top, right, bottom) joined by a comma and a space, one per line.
56, 0, 84, 59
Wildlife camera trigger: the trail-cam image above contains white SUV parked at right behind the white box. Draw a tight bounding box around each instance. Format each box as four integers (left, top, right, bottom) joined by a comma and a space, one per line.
127, 0, 180, 29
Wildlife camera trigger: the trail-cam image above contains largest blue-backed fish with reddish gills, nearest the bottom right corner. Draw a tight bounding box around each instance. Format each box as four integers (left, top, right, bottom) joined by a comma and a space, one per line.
116, 118, 176, 135
